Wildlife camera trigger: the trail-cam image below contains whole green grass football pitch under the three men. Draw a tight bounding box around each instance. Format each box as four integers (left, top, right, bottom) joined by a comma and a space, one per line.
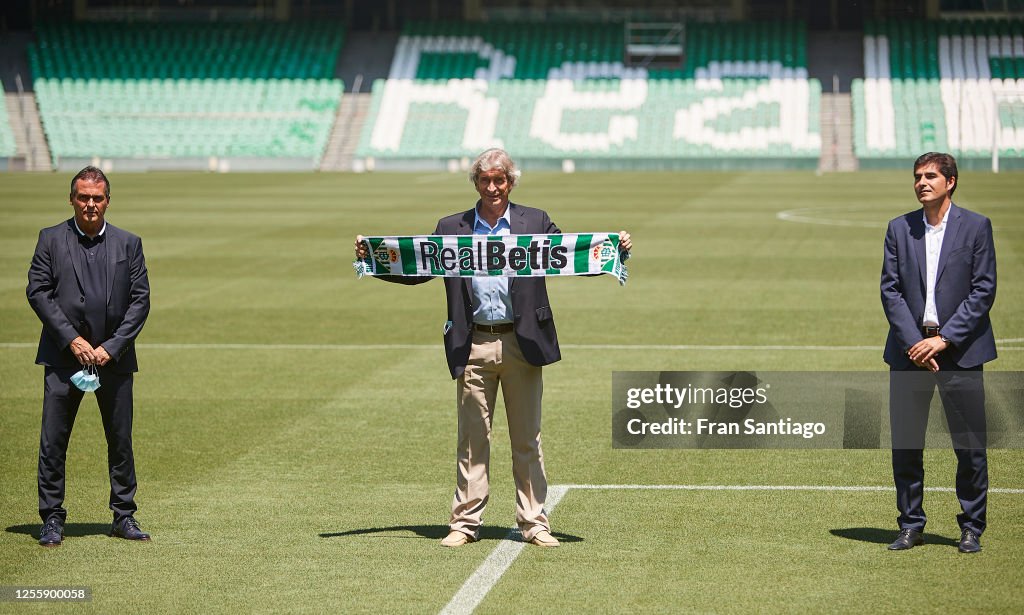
0, 169, 1024, 613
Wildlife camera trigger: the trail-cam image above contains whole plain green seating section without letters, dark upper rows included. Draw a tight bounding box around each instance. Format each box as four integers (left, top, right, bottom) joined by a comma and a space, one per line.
29, 23, 344, 169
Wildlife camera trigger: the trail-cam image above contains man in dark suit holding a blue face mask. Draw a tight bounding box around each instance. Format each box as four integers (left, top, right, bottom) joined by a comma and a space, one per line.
27, 167, 150, 546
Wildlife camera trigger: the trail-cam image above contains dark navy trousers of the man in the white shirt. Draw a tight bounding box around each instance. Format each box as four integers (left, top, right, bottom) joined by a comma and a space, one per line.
889, 355, 988, 536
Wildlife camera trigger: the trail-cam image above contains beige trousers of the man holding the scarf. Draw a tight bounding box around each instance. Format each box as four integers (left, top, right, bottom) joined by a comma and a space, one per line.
450, 330, 550, 540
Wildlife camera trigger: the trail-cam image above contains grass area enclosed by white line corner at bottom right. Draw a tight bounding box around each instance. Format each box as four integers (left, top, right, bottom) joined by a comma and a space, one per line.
483, 489, 1024, 614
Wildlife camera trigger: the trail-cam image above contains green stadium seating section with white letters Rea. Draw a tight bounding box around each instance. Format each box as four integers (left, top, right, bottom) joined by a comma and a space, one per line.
357, 23, 821, 166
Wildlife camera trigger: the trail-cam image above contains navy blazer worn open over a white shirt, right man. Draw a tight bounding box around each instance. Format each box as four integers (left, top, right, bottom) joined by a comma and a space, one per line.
882, 205, 996, 369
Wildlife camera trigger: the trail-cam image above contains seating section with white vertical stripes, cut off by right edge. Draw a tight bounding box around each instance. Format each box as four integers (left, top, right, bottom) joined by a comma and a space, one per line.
853, 19, 1024, 166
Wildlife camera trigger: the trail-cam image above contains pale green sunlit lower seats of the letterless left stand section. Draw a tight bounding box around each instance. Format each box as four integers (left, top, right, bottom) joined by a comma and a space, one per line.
36, 79, 342, 160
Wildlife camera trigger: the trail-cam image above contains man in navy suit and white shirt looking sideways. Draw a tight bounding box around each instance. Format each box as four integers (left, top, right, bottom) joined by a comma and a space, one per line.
882, 152, 995, 553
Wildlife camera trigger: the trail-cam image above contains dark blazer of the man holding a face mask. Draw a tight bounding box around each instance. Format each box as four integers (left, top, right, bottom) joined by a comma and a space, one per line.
26, 218, 150, 372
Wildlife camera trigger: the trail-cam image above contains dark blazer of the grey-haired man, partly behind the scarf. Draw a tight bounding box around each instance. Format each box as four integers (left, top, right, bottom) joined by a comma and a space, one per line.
380, 203, 562, 379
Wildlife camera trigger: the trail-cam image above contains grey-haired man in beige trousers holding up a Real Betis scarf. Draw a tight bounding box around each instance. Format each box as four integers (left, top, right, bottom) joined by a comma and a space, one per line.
355, 149, 632, 546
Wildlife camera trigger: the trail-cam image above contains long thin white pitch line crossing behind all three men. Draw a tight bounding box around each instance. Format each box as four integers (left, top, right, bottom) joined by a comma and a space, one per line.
0, 339, 1024, 352
